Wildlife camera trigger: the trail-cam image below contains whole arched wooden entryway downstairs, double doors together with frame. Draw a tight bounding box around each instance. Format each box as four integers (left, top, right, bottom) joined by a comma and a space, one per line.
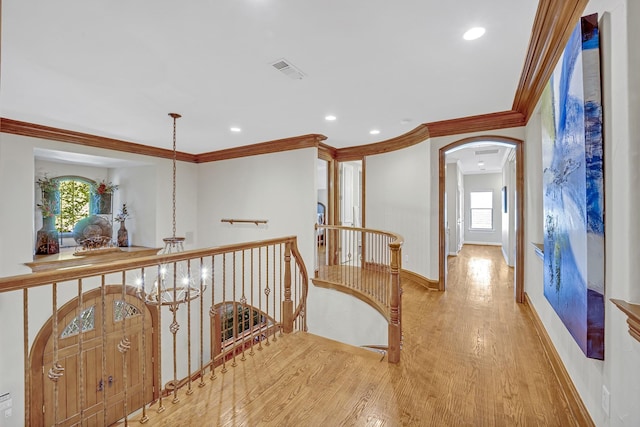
29, 285, 158, 425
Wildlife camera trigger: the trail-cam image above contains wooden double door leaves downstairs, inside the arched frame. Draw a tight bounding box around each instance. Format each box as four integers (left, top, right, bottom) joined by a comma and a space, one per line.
39, 293, 154, 426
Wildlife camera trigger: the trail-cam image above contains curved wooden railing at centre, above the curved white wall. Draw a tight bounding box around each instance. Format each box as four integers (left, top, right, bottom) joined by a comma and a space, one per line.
313, 225, 403, 363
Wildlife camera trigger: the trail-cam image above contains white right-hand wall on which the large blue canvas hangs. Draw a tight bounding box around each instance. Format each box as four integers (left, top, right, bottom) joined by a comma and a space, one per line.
525, 0, 640, 426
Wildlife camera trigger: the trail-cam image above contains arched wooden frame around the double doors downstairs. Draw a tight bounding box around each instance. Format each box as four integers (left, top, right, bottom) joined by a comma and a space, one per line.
25, 285, 160, 425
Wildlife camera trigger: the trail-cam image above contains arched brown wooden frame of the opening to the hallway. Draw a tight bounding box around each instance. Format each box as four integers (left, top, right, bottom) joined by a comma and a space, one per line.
438, 135, 525, 303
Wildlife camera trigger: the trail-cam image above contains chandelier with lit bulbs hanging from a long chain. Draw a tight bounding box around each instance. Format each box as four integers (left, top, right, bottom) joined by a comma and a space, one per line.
138, 113, 200, 311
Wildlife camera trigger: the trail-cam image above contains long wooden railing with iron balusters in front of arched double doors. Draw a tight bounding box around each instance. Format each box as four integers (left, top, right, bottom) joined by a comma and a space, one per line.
0, 237, 308, 425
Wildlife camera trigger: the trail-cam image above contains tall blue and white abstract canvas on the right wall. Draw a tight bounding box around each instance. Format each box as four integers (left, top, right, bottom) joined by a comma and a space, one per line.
541, 14, 604, 359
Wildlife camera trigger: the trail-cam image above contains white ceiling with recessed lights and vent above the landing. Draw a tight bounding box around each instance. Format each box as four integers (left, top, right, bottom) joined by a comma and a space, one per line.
0, 0, 538, 154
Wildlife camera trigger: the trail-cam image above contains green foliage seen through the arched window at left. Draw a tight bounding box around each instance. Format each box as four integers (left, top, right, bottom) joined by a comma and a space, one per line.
56, 179, 91, 232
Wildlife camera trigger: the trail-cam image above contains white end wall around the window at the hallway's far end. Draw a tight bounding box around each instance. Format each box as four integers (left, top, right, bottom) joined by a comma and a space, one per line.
464, 173, 502, 246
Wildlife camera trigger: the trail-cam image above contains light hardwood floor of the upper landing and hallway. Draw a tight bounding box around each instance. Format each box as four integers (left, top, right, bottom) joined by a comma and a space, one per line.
115, 246, 576, 426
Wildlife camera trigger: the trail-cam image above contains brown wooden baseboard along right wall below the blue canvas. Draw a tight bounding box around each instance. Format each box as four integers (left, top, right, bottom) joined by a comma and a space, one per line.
524, 293, 595, 426
